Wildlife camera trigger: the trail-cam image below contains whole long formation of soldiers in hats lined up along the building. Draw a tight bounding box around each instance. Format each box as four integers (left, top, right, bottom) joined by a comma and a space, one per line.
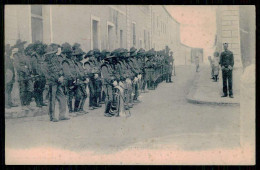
5, 40, 173, 122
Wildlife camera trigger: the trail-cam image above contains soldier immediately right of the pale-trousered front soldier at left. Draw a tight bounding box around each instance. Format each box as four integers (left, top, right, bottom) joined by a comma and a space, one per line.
61, 43, 78, 116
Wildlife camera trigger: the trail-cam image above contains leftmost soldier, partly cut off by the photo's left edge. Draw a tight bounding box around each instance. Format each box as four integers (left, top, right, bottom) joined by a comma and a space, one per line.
5, 44, 18, 108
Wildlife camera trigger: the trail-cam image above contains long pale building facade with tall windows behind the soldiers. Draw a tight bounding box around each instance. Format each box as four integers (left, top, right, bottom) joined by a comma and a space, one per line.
5, 5, 180, 55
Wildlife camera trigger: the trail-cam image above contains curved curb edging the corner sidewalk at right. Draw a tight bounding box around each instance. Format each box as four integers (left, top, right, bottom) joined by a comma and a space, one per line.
186, 66, 240, 106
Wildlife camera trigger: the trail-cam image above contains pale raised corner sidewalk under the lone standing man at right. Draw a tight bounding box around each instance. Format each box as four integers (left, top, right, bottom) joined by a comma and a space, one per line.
187, 65, 242, 106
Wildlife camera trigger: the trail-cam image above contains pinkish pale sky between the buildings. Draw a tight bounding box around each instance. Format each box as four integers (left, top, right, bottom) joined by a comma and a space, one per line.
165, 5, 216, 57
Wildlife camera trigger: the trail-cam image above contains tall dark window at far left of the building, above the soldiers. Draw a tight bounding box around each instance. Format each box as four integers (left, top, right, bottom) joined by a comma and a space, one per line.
31, 5, 43, 43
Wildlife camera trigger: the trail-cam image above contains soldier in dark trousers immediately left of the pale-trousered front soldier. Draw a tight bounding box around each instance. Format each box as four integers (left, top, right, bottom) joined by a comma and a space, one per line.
30, 41, 47, 107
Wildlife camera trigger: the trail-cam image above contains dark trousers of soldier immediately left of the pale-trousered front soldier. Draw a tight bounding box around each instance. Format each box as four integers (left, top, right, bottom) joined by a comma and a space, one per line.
34, 77, 46, 106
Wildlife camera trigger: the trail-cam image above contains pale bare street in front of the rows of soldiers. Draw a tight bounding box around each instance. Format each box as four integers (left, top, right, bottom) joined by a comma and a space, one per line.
5, 66, 240, 153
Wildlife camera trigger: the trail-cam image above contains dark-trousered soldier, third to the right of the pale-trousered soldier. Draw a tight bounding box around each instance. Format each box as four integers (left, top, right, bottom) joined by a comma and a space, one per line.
84, 50, 101, 110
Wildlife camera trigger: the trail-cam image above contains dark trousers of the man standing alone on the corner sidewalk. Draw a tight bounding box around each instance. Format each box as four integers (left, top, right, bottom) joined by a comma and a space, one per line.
222, 70, 233, 95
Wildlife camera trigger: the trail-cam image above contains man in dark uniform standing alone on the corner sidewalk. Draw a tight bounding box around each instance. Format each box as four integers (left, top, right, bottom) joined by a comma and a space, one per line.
219, 43, 234, 98
